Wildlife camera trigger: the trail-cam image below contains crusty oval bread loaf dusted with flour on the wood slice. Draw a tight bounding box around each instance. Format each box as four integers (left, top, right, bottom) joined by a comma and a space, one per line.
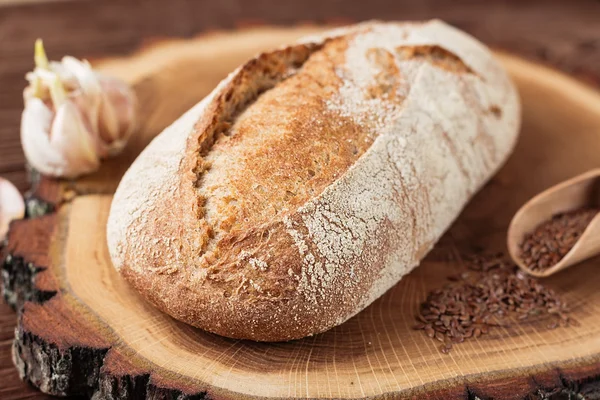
107, 20, 520, 341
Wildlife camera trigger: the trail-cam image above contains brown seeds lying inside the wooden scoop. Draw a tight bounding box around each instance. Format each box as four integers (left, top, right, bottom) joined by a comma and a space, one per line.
520, 207, 600, 271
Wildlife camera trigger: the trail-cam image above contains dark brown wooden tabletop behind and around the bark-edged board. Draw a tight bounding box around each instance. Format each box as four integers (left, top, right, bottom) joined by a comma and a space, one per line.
0, 0, 600, 400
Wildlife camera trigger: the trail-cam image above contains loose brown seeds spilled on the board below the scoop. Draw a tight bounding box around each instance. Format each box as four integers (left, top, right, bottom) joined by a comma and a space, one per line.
414, 254, 577, 353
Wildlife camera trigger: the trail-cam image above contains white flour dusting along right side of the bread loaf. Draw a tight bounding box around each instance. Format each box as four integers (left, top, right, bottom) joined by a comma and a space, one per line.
288, 21, 518, 311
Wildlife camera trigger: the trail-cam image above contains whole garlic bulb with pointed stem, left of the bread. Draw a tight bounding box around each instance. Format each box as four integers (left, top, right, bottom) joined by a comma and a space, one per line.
21, 39, 136, 178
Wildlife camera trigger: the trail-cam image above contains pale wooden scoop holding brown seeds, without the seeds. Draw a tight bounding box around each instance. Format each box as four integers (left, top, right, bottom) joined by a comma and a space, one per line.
508, 168, 600, 277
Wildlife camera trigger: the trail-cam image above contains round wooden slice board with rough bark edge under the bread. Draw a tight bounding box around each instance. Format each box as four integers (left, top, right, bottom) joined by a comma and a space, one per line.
2, 27, 600, 399
